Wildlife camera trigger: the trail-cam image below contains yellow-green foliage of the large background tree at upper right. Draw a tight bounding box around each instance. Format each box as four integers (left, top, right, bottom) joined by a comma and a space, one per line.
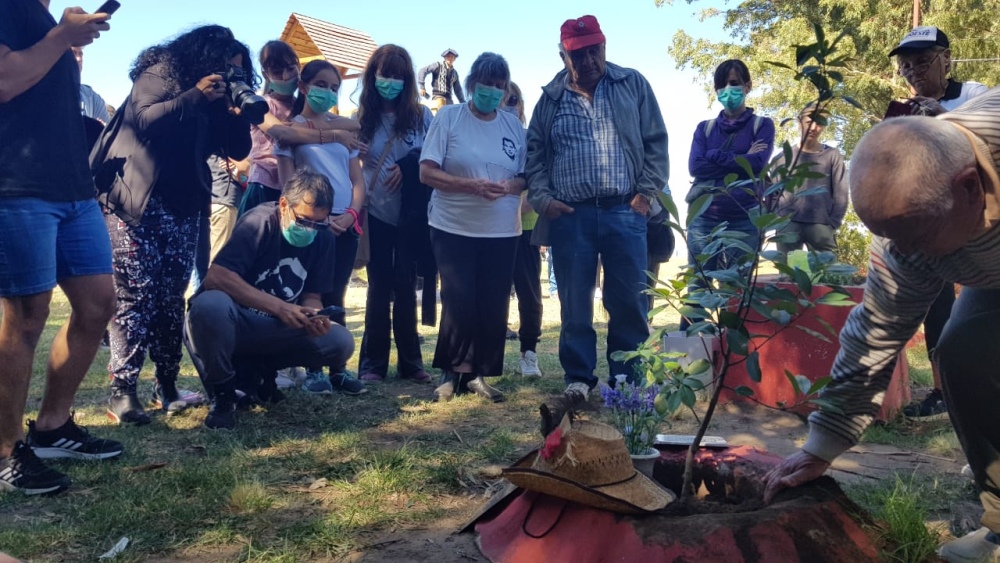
654, 0, 1000, 155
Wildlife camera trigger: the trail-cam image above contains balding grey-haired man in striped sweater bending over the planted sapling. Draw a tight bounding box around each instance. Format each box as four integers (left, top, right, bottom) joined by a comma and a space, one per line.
765, 89, 1000, 561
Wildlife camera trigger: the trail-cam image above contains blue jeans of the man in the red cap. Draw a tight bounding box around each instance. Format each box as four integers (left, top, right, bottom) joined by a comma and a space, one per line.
549, 202, 649, 388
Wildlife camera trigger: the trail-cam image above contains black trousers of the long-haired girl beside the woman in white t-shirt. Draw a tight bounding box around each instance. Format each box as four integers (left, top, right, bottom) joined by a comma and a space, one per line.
358, 214, 424, 377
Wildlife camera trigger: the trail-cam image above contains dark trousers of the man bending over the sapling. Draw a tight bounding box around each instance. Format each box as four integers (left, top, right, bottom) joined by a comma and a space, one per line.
934, 287, 1000, 532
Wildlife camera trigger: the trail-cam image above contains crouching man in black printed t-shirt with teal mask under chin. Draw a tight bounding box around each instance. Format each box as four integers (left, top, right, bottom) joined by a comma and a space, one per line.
184, 170, 354, 429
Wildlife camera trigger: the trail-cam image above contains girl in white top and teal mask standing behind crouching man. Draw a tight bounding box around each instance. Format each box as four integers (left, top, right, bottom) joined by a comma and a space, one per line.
274, 60, 366, 395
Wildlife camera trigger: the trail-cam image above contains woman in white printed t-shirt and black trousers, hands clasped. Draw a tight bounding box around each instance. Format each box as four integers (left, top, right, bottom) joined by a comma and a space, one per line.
420, 53, 526, 402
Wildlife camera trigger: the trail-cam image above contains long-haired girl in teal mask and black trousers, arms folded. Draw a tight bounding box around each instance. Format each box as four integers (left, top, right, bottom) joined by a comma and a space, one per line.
358, 44, 432, 383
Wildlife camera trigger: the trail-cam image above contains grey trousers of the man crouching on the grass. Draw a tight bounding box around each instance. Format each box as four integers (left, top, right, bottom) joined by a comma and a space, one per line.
184, 290, 354, 394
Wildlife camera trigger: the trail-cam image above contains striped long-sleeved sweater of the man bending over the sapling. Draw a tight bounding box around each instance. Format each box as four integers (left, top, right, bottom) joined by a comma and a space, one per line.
802, 88, 1000, 461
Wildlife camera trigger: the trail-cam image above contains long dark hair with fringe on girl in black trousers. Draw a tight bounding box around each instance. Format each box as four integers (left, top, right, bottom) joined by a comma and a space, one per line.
358, 45, 424, 143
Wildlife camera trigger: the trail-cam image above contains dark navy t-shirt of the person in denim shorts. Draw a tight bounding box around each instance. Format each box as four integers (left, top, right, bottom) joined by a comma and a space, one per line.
0, 0, 94, 201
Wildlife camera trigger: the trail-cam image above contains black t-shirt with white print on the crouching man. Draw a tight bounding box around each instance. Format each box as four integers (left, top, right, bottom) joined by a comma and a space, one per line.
214, 202, 336, 303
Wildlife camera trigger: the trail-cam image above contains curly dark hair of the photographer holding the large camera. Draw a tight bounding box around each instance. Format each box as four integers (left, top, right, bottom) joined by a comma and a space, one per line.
128, 25, 259, 99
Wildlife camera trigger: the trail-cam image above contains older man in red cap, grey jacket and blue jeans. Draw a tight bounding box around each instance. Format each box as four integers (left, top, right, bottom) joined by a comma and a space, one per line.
525, 16, 669, 396
